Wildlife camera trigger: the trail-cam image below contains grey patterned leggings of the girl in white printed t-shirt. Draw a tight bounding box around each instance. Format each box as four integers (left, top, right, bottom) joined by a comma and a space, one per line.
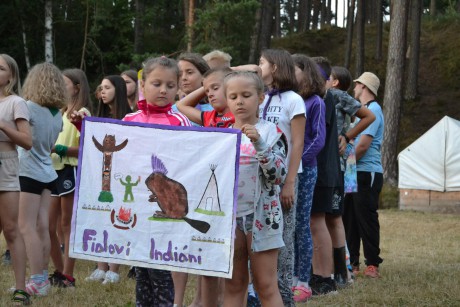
278, 177, 298, 307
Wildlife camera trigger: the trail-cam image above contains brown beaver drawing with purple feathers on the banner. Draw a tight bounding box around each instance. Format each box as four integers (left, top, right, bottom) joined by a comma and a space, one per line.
145, 155, 211, 233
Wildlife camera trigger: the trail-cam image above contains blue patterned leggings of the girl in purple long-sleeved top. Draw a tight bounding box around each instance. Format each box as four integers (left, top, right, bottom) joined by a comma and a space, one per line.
294, 166, 318, 282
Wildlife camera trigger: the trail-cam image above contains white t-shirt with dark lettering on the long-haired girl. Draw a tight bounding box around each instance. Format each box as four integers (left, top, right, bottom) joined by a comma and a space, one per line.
259, 91, 306, 173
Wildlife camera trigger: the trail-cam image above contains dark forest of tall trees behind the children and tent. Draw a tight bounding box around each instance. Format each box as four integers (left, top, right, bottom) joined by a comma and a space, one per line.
0, 0, 460, 197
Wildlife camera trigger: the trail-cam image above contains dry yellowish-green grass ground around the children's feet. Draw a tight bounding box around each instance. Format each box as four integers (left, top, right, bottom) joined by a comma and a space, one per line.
0, 209, 460, 306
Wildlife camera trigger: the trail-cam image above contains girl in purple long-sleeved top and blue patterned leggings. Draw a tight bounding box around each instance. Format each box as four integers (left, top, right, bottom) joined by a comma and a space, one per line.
292, 54, 326, 302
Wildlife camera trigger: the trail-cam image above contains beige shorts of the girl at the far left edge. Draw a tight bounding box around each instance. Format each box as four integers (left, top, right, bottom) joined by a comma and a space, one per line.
0, 150, 21, 192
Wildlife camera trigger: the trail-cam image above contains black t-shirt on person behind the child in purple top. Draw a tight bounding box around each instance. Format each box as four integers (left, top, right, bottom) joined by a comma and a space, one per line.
316, 91, 343, 188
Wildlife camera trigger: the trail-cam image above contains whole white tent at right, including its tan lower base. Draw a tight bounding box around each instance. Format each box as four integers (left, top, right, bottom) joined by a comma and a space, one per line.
398, 116, 460, 214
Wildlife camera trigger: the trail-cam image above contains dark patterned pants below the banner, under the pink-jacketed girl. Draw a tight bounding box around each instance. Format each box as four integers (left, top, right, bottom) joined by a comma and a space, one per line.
136, 267, 174, 307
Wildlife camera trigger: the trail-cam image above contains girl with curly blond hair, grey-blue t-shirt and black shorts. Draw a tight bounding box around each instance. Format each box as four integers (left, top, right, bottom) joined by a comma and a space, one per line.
18, 63, 68, 296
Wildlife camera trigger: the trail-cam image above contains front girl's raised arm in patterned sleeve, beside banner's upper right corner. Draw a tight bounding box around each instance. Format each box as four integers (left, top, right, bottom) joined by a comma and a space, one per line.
241, 125, 287, 185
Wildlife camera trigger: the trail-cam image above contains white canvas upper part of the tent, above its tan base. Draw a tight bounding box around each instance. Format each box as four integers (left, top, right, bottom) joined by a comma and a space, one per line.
398, 116, 460, 192
